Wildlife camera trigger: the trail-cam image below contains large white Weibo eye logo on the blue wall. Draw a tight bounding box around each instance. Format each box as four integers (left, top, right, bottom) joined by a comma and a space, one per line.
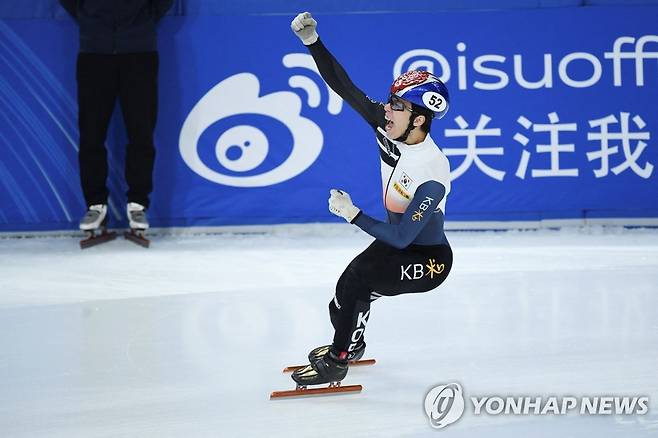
179, 54, 342, 187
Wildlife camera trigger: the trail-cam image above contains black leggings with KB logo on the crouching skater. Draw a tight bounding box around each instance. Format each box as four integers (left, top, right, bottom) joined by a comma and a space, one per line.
329, 240, 452, 351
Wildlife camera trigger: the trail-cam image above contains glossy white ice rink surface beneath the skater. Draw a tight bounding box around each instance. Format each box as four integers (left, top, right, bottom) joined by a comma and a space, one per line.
0, 225, 658, 438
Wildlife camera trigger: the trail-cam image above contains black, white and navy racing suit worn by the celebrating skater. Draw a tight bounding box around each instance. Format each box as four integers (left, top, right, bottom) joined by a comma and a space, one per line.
308, 40, 452, 351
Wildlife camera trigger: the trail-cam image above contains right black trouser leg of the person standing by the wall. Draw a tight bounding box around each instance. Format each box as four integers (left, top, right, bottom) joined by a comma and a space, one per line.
119, 52, 158, 207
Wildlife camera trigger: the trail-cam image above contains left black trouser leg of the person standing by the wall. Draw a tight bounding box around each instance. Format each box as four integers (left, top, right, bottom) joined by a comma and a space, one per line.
76, 53, 118, 206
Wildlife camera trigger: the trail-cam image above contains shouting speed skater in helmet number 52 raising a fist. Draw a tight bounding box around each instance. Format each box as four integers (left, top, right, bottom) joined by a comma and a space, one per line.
291, 12, 452, 386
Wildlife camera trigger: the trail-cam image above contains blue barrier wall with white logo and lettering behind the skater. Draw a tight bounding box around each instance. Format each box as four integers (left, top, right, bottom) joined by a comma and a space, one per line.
0, 1, 658, 231
